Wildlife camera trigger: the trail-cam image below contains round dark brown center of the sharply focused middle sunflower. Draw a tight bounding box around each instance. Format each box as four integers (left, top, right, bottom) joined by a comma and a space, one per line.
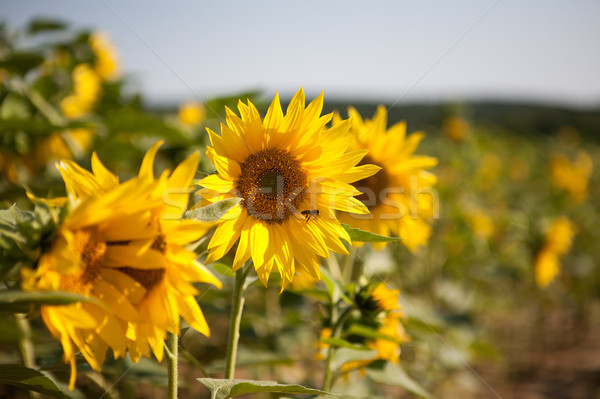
235, 149, 308, 224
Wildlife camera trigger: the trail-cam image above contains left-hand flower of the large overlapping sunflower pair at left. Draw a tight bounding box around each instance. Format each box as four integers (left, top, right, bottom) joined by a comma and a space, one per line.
22, 173, 158, 388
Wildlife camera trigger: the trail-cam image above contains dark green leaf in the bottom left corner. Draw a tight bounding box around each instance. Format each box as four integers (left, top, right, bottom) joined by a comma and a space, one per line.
0, 364, 68, 398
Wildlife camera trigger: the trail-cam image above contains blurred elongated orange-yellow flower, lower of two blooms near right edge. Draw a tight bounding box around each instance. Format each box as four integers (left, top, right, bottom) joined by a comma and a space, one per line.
535, 216, 576, 288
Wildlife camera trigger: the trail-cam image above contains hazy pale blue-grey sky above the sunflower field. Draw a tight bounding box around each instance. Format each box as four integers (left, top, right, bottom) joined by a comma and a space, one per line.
0, 0, 600, 105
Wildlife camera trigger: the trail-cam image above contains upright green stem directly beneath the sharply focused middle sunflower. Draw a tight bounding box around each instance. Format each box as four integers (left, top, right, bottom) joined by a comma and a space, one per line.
225, 264, 252, 379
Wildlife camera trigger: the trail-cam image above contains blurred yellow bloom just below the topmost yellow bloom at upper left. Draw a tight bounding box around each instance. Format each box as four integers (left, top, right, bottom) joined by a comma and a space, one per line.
60, 64, 101, 119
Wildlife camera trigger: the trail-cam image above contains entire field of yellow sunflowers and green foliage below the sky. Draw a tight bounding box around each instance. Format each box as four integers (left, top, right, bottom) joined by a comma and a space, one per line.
0, 20, 600, 399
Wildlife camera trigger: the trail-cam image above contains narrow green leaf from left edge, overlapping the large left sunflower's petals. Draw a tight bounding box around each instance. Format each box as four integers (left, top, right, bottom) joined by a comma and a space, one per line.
0, 290, 95, 313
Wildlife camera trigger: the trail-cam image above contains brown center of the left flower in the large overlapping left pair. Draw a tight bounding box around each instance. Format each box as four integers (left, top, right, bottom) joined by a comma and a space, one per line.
60, 228, 106, 293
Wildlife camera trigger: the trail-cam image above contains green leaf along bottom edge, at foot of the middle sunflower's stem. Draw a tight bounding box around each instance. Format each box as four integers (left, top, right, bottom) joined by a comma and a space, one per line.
198, 378, 335, 399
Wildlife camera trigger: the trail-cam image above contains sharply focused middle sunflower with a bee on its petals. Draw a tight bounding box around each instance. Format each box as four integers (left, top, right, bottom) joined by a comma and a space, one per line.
199, 90, 379, 289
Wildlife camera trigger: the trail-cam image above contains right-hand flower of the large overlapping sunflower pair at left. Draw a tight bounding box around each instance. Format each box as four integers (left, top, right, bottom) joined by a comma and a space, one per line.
125, 142, 221, 361
